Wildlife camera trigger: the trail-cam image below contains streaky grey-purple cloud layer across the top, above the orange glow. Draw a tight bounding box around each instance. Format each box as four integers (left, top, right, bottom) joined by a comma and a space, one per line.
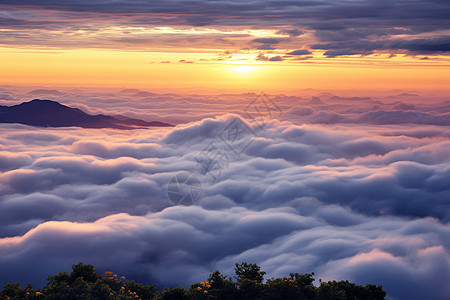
0, 0, 450, 58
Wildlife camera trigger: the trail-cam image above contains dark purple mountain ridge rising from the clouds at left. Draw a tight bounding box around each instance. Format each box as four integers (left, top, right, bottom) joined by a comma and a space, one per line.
0, 99, 173, 129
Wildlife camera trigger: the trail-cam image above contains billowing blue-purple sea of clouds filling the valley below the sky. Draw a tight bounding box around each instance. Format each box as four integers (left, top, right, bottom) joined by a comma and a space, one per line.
0, 87, 450, 300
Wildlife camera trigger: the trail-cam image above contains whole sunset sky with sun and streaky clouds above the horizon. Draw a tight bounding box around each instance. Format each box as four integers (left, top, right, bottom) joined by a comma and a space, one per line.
0, 0, 450, 92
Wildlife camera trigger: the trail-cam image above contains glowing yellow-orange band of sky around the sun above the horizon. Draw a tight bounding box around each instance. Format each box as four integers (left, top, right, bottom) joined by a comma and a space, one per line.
0, 48, 450, 93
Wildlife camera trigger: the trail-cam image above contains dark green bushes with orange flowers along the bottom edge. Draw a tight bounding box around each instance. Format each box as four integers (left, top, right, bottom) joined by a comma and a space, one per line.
0, 262, 386, 300
